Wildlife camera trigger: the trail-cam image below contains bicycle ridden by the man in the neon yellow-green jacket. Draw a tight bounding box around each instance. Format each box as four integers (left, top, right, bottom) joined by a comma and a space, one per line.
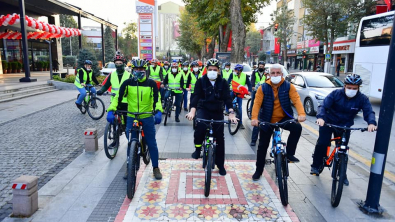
124, 110, 153, 199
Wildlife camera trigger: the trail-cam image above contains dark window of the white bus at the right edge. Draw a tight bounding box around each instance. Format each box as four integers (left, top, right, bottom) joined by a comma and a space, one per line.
359, 15, 394, 47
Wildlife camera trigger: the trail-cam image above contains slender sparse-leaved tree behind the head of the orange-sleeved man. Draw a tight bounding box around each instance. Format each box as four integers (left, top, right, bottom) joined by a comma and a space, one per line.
270, 0, 295, 67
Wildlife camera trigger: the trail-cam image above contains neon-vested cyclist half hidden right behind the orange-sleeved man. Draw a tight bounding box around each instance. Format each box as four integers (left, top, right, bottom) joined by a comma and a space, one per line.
249, 61, 266, 146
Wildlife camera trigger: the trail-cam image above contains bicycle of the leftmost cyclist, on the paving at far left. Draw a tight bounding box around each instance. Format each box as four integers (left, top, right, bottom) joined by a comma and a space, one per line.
77, 86, 104, 120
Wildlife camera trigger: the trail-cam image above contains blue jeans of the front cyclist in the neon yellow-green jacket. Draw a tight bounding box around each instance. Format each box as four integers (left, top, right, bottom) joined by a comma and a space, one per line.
126, 116, 159, 167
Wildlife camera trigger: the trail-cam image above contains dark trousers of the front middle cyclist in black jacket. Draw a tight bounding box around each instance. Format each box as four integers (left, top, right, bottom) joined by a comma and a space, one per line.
194, 109, 225, 168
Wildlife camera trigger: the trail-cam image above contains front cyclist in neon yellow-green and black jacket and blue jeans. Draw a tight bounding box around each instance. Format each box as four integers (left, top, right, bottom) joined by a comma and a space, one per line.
107, 59, 162, 180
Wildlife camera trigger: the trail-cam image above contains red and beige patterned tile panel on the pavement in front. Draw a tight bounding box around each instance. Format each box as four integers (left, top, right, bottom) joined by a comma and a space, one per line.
115, 160, 299, 221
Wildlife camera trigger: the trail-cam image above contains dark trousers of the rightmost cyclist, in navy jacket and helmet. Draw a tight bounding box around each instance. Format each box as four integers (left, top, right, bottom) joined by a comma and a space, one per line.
311, 126, 350, 168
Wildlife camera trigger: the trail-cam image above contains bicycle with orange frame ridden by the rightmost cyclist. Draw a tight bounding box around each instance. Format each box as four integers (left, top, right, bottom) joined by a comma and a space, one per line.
319, 124, 368, 207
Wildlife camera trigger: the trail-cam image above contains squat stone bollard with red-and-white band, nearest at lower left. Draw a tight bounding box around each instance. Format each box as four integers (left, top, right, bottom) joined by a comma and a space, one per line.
12, 175, 38, 217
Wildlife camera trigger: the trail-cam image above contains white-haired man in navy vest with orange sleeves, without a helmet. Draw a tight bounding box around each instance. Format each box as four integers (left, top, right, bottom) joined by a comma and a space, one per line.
251, 64, 306, 180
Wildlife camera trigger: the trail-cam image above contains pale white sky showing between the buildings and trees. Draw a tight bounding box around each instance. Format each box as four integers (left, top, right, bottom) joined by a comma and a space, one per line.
61, 0, 276, 33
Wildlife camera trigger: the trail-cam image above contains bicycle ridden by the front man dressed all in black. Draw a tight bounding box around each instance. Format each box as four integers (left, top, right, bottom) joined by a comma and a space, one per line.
196, 118, 230, 197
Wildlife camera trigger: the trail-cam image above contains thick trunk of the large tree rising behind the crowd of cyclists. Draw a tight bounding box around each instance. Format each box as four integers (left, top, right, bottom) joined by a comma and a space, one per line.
230, 0, 246, 63
